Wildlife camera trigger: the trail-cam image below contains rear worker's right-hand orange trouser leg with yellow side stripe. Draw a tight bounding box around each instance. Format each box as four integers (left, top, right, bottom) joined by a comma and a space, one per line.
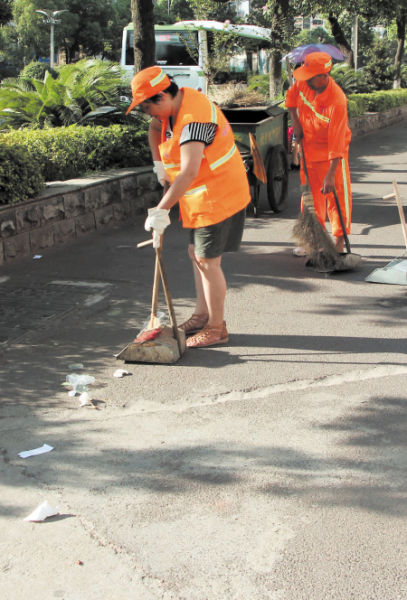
327, 157, 352, 240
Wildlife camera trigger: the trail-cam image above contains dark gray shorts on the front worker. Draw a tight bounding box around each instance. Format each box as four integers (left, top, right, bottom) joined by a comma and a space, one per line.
189, 208, 246, 258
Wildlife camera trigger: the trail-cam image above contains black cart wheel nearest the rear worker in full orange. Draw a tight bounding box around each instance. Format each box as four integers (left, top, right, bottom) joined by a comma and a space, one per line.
266, 146, 288, 212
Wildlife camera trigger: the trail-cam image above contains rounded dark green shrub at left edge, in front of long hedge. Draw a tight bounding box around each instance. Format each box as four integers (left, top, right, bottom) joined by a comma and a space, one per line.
0, 140, 45, 204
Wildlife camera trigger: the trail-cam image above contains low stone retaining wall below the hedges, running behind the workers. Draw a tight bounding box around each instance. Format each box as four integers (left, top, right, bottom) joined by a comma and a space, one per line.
0, 105, 407, 265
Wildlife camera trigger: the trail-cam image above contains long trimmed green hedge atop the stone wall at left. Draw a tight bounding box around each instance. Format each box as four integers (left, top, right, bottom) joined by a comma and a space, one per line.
0, 125, 151, 204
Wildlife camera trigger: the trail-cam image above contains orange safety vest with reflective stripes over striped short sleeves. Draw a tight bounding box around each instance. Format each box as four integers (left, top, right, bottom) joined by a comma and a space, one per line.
159, 88, 250, 229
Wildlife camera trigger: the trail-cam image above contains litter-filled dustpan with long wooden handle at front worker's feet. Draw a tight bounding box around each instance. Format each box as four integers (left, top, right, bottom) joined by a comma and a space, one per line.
116, 240, 185, 364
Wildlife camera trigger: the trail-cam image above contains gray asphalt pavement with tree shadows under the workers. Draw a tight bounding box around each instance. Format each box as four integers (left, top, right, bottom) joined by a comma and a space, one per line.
0, 121, 407, 600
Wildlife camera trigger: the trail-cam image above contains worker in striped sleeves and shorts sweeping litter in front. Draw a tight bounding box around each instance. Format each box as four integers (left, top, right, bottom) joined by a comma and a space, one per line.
127, 66, 250, 348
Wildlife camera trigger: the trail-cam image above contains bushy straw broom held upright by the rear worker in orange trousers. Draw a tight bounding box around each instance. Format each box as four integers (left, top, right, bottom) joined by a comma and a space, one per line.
292, 143, 338, 272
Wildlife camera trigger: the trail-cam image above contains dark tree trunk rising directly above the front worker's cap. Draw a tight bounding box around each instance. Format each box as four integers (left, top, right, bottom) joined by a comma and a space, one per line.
131, 0, 155, 73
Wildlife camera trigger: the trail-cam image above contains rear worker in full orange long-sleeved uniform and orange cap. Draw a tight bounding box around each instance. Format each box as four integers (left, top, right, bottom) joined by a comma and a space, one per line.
286, 52, 352, 256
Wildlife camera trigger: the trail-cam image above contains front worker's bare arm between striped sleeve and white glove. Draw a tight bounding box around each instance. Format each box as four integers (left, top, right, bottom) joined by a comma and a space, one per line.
157, 142, 205, 210
